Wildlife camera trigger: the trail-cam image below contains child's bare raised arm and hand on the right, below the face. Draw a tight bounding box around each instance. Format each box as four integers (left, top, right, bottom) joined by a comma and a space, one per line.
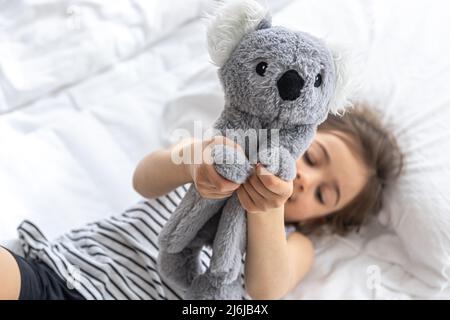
237, 166, 314, 300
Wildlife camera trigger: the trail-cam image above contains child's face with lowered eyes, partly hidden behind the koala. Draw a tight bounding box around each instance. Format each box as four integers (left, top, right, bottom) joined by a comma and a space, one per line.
284, 131, 368, 222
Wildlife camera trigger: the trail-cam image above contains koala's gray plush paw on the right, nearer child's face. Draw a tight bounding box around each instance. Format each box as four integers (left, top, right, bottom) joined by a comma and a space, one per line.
258, 148, 297, 181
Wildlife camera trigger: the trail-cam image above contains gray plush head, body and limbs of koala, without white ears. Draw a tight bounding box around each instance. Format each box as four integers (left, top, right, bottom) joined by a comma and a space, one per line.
158, 5, 336, 299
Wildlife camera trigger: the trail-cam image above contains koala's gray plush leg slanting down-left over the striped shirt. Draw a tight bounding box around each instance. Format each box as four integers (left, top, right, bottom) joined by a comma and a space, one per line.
158, 186, 227, 253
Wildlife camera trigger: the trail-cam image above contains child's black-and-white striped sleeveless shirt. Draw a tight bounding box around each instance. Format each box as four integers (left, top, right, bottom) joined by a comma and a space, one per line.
18, 186, 298, 300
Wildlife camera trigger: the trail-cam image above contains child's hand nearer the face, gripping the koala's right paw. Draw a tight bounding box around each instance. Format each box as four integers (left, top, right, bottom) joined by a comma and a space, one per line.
236, 164, 293, 213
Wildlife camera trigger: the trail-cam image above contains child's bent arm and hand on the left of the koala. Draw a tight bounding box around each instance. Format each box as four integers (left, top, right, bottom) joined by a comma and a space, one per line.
133, 137, 239, 199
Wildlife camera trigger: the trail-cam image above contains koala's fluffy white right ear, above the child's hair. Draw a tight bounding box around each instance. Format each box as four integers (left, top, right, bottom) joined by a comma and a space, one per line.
328, 43, 361, 115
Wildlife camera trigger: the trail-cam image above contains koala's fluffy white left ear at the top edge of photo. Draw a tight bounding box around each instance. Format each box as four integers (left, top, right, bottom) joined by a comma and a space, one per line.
207, 0, 271, 67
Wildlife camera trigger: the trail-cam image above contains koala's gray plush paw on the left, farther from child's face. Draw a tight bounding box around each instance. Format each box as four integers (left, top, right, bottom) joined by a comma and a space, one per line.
212, 145, 253, 184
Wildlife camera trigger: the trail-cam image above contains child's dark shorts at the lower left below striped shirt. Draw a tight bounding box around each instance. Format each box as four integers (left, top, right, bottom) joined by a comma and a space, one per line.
8, 250, 85, 300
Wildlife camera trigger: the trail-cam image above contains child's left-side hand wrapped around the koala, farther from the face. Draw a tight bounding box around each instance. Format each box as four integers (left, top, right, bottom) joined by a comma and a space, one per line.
186, 136, 242, 199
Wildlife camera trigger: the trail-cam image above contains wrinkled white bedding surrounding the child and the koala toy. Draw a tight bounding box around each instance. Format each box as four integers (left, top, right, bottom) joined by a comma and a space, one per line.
0, 0, 450, 299
